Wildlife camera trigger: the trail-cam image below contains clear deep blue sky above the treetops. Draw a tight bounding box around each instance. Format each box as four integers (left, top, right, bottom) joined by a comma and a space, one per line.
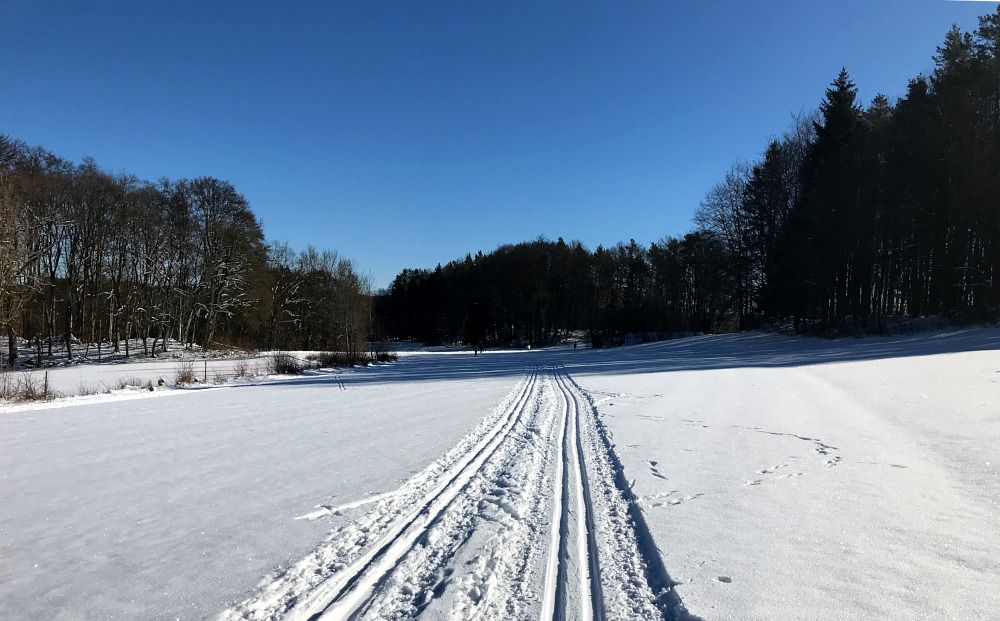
0, 0, 996, 285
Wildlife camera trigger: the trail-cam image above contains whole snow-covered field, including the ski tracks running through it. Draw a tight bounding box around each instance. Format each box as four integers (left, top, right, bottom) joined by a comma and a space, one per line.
0, 329, 1000, 620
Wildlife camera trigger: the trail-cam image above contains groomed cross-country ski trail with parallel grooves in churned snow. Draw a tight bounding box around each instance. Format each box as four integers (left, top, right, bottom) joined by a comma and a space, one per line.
219, 368, 687, 621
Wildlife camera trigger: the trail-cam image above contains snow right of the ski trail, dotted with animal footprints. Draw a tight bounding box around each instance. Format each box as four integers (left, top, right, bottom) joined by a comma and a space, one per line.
581, 330, 1000, 619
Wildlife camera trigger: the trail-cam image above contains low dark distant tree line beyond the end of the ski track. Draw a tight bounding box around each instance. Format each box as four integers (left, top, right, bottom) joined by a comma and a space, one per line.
376, 231, 729, 347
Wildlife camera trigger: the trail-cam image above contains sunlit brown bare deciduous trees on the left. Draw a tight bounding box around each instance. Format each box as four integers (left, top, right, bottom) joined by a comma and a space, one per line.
0, 134, 371, 364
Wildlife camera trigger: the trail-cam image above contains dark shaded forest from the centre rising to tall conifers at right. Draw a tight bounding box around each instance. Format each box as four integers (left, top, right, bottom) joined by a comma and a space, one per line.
377, 9, 1000, 344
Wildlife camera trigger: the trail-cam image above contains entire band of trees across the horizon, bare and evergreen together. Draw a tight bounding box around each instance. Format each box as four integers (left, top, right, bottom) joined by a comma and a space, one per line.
0, 9, 1000, 361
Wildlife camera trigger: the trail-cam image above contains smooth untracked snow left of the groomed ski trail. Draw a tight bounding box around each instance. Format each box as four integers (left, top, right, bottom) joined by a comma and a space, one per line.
0, 369, 511, 620
